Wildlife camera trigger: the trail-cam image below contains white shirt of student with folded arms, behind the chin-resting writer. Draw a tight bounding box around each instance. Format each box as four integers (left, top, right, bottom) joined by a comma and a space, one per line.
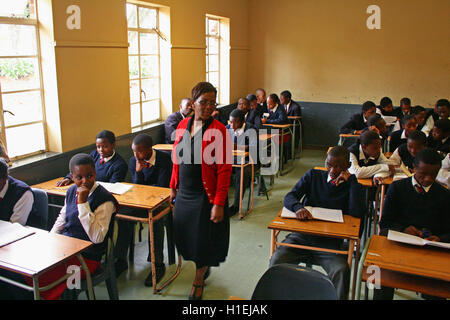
348, 145, 390, 179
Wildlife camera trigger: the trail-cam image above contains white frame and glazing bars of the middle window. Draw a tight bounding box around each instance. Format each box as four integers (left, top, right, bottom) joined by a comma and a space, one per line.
126, 1, 162, 132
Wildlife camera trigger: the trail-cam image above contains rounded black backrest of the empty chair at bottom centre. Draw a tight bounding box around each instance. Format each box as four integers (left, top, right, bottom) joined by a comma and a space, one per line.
252, 264, 338, 300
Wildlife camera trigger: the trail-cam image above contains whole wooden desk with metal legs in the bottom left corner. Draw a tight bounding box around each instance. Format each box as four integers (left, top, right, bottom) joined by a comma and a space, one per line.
0, 228, 94, 300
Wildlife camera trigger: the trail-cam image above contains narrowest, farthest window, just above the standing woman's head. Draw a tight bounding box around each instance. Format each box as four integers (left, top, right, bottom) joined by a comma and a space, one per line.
206, 16, 220, 102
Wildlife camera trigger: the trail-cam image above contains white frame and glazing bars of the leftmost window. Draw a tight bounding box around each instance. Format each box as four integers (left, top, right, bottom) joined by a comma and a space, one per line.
0, 7, 48, 161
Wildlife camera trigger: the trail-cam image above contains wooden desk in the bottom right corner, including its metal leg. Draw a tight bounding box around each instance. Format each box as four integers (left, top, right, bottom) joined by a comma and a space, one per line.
356, 235, 450, 299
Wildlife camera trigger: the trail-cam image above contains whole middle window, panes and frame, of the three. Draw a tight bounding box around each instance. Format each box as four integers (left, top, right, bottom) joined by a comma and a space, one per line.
127, 3, 161, 129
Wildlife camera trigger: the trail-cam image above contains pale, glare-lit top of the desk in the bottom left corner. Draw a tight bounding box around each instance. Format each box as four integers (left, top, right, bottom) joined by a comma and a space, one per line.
0, 228, 93, 276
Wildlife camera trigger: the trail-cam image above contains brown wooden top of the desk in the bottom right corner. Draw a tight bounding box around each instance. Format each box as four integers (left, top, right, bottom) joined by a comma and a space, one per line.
364, 235, 450, 281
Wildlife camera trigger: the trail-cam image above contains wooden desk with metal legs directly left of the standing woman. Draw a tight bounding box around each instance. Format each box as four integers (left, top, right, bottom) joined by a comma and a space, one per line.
32, 178, 181, 293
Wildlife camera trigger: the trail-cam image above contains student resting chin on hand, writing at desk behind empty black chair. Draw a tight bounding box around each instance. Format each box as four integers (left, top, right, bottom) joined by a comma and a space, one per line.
270, 146, 366, 299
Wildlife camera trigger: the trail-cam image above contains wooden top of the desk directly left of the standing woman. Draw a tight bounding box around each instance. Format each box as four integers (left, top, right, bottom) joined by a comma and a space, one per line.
31, 178, 170, 210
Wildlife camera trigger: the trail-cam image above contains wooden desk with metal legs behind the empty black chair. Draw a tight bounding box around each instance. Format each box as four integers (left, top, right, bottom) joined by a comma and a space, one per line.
268, 211, 360, 300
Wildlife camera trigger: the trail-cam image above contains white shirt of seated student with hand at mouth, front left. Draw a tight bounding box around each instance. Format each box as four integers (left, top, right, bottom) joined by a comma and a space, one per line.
50, 182, 116, 243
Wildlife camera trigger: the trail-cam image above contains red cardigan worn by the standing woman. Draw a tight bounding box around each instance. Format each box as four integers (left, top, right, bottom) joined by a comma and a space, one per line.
170, 118, 233, 206
